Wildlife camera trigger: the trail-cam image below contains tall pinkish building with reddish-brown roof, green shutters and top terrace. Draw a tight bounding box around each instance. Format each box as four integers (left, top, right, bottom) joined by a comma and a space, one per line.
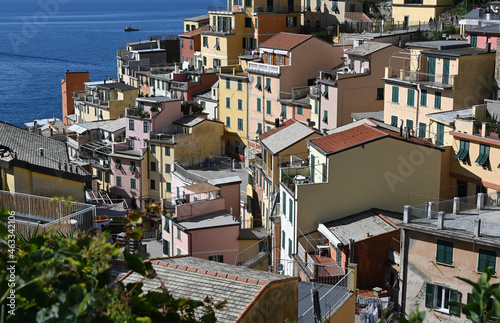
247, 33, 342, 144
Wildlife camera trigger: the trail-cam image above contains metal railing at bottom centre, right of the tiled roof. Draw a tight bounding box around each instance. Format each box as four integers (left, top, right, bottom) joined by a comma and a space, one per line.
299, 271, 354, 322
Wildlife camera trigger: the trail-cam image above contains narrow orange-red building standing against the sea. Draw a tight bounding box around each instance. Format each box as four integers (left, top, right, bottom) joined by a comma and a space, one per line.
61, 70, 90, 125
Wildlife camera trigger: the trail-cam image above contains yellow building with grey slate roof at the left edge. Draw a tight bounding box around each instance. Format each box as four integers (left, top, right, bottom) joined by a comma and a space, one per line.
0, 122, 92, 202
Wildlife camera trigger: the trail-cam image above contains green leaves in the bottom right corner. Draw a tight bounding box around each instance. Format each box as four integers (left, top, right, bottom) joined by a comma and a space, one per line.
451, 267, 500, 323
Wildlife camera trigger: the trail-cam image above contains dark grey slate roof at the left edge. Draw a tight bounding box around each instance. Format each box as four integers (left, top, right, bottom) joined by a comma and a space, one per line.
0, 121, 90, 181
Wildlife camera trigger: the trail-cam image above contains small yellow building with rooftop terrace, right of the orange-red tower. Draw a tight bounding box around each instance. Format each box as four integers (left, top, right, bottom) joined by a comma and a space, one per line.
73, 81, 139, 123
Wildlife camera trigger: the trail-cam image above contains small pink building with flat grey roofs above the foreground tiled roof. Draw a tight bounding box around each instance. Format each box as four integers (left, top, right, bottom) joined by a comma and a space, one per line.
162, 183, 240, 264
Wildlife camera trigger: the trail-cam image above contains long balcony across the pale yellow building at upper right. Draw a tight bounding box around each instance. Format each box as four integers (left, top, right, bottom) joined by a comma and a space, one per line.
385, 67, 456, 90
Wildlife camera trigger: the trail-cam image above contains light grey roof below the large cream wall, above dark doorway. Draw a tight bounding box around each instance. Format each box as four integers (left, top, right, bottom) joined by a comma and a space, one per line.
324, 209, 403, 245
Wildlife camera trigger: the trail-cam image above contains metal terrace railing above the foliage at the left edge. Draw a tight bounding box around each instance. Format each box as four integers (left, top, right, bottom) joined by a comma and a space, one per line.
0, 191, 96, 234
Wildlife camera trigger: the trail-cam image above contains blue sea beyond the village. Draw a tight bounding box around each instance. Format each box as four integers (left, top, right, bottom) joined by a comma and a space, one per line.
0, 0, 219, 127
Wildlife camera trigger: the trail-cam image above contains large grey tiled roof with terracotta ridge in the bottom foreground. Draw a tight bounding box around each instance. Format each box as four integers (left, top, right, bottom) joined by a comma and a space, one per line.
116, 257, 298, 322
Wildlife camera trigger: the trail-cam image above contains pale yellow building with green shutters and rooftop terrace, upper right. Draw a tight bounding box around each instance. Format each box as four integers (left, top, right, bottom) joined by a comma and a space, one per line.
384, 41, 495, 138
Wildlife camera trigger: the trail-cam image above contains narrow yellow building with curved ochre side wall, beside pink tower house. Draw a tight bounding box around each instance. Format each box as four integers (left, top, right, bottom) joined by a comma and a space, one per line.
142, 116, 224, 201
